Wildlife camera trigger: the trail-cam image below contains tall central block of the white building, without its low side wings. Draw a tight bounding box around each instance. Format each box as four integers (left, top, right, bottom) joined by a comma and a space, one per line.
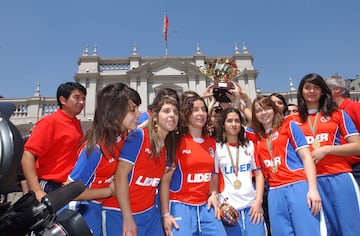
75, 42, 258, 119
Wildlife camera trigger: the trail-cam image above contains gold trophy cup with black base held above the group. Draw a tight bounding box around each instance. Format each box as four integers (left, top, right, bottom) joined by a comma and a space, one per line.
200, 58, 239, 102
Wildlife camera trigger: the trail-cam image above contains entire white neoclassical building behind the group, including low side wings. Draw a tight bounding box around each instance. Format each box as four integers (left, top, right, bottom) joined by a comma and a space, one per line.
0, 43, 360, 133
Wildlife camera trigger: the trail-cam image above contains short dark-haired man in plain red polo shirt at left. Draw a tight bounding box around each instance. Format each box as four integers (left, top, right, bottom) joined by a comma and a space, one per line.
21, 82, 86, 201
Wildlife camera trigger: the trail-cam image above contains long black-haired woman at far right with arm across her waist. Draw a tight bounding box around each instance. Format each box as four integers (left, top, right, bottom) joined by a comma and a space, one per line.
292, 74, 360, 235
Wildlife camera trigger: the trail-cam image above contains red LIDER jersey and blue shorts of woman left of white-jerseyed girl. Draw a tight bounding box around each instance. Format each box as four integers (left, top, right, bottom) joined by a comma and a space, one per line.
169, 135, 226, 236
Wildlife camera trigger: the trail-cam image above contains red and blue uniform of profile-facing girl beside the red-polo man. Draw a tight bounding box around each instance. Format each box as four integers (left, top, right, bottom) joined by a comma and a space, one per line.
69, 136, 124, 235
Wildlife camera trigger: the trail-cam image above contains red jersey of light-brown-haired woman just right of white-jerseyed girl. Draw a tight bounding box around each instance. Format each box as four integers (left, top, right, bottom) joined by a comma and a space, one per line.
246, 120, 308, 188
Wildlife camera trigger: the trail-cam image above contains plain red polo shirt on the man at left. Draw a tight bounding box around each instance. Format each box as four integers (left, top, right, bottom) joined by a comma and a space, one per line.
24, 109, 83, 182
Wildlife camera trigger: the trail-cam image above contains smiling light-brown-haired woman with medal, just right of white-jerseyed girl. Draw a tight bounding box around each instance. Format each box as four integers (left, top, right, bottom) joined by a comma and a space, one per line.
248, 97, 321, 235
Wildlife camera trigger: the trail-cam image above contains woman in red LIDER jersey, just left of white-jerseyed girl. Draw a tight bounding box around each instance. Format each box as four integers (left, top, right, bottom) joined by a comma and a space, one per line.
160, 95, 226, 236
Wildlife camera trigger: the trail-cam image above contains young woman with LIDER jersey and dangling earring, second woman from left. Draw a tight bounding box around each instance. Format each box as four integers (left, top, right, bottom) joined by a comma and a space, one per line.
113, 96, 179, 236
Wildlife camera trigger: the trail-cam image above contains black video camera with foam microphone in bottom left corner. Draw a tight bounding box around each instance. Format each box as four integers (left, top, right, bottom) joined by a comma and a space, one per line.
0, 181, 92, 236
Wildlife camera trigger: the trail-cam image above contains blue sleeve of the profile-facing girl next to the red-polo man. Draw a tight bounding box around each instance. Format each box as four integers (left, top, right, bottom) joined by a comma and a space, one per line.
69, 146, 102, 187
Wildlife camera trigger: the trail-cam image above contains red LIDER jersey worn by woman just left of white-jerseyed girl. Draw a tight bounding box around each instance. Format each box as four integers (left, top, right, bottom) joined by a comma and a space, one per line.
170, 135, 216, 205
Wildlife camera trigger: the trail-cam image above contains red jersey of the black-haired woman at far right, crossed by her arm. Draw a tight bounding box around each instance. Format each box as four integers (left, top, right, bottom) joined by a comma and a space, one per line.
291, 109, 359, 175
